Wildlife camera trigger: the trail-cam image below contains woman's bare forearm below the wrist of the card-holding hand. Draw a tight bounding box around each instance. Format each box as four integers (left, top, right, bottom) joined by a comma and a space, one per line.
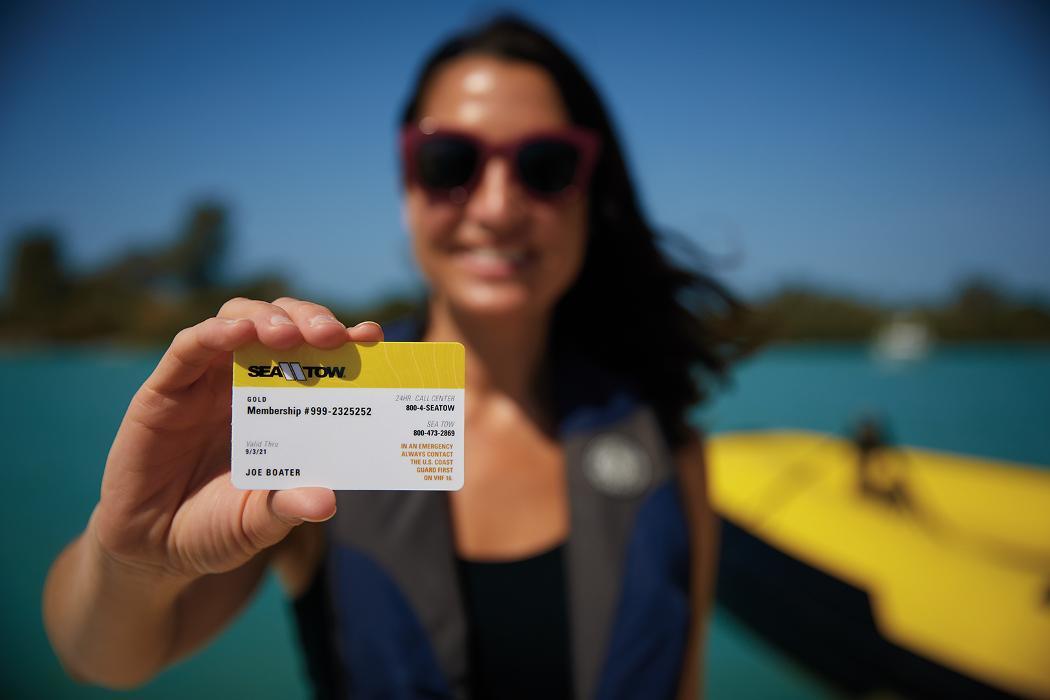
43, 524, 186, 687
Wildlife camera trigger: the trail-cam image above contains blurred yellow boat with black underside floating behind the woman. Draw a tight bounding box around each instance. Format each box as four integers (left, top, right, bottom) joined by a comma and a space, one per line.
709, 431, 1050, 698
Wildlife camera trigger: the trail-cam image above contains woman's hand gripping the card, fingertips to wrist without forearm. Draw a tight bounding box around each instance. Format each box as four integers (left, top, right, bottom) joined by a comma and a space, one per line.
89, 298, 383, 579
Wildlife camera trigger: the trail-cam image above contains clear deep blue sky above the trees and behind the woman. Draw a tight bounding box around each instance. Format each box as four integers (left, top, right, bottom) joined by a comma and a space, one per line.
0, 0, 1050, 303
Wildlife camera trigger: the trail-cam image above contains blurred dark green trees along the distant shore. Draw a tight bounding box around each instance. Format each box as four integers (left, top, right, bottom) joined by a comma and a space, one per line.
0, 204, 1050, 344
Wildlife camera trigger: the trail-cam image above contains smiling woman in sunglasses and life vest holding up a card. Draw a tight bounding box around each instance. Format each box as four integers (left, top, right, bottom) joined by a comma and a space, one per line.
44, 18, 736, 697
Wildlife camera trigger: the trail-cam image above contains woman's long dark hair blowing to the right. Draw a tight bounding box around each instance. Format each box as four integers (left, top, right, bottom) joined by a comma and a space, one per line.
401, 15, 747, 447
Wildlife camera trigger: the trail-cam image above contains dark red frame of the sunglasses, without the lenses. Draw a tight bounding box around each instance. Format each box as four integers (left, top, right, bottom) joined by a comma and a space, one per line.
401, 125, 602, 204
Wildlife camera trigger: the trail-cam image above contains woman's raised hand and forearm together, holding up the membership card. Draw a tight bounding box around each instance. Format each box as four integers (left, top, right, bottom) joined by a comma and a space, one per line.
43, 298, 383, 687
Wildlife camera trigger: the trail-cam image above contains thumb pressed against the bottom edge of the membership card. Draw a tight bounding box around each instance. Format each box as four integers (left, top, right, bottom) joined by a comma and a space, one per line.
244, 486, 335, 549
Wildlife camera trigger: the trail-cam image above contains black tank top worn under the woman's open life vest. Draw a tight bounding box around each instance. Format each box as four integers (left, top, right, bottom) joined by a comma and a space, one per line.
294, 545, 572, 700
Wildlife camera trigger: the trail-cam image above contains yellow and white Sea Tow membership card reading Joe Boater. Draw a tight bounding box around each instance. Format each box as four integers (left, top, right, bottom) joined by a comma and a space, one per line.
231, 342, 464, 491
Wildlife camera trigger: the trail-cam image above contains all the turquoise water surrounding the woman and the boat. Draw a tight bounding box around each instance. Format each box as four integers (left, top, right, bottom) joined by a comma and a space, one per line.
0, 346, 1050, 699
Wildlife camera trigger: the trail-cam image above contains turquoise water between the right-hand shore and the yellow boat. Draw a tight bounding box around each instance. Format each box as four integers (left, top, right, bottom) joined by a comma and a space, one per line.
698, 344, 1050, 466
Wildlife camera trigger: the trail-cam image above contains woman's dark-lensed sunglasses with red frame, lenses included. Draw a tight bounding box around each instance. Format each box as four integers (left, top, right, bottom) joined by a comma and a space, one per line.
401, 125, 601, 204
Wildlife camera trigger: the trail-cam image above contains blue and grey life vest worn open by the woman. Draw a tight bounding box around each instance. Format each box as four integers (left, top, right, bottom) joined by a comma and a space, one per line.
312, 322, 690, 698
